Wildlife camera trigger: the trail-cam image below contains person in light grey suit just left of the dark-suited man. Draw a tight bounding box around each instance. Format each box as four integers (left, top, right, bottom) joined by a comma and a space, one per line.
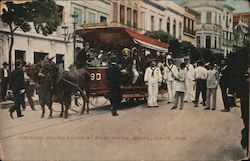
204, 63, 219, 110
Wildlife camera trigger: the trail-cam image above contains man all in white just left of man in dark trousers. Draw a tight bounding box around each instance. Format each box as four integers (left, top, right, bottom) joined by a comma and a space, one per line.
184, 56, 195, 102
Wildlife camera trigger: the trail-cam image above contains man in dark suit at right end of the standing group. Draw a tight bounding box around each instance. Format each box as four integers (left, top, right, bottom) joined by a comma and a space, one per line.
220, 59, 231, 112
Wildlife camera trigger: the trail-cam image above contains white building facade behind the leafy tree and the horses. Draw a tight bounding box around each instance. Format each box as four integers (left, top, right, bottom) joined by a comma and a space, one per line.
0, 0, 110, 69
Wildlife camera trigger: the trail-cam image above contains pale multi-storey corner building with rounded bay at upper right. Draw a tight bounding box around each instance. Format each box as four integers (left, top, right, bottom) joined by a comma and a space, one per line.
185, 0, 234, 57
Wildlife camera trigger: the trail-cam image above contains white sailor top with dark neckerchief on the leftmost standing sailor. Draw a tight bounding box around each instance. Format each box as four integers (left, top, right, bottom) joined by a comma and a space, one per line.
144, 67, 162, 83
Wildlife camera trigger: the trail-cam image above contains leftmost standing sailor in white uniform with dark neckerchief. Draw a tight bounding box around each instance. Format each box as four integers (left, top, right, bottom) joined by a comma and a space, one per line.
144, 59, 162, 107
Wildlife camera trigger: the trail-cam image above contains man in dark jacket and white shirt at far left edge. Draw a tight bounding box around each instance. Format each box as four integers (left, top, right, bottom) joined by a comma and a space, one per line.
0, 62, 9, 101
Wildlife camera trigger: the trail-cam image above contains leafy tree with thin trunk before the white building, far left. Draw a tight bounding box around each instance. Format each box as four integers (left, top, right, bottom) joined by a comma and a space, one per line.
1, 0, 61, 70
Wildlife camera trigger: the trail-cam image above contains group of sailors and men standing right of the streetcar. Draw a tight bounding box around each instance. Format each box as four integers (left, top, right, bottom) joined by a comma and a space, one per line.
144, 55, 236, 112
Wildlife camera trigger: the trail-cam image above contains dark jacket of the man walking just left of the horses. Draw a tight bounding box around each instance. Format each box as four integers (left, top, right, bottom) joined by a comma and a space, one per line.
9, 69, 25, 93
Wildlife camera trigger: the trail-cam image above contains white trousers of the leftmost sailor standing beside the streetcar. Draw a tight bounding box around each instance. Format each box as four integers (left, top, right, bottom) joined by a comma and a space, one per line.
148, 83, 159, 106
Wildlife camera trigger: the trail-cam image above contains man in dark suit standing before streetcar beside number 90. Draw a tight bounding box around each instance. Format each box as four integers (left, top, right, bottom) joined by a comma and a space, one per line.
107, 56, 122, 116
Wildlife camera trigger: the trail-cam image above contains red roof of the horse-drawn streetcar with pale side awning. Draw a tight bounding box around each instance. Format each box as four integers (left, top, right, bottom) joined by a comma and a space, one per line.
76, 27, 169, 52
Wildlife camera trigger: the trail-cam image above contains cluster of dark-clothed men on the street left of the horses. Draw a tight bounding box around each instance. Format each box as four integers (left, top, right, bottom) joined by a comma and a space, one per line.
0, 60, 36, 119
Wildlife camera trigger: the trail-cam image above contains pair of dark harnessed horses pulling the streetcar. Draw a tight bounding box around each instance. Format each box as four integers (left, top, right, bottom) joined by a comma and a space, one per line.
32, 58, 90, 118
